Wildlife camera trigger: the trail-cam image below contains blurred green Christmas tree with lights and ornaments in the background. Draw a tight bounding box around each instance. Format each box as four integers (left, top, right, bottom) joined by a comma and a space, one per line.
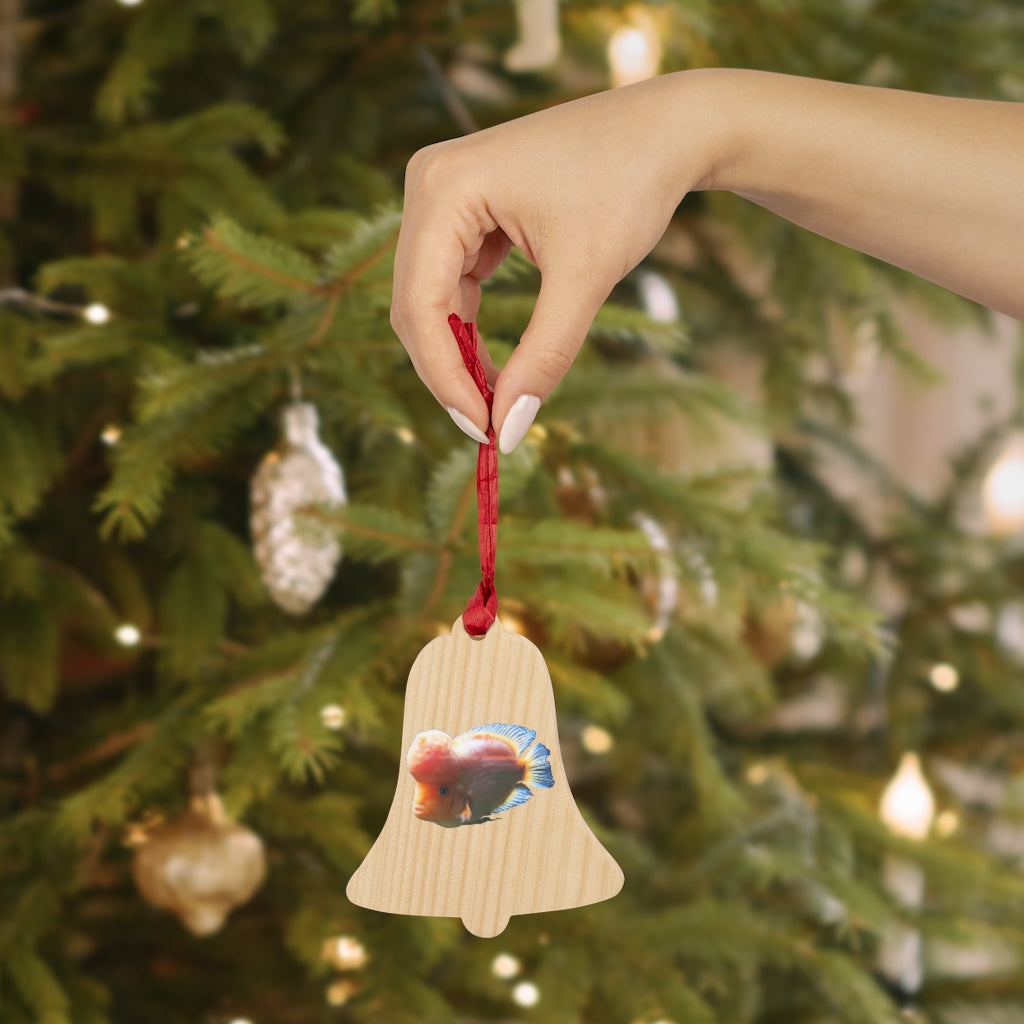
6, 0, 1024, 1024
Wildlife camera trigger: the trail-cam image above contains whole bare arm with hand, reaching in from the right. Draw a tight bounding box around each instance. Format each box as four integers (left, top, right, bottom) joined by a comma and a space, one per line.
391, 61, 1024, 452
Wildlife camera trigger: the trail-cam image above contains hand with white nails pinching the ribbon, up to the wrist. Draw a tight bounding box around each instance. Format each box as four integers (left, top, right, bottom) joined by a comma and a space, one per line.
391, 73, 711, 453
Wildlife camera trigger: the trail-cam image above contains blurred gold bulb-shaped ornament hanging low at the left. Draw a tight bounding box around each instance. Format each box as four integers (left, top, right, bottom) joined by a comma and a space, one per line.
132, 794, 266, 936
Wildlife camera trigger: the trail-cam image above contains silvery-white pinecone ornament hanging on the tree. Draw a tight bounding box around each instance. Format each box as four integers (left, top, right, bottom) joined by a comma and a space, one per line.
250, 401, 346, 615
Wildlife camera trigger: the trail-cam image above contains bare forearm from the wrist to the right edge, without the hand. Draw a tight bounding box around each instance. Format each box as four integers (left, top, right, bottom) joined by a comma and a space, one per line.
680, 71, 1024, 318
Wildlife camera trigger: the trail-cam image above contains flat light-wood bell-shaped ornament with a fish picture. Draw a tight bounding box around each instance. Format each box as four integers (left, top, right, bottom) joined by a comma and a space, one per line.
347, 617, 624, 938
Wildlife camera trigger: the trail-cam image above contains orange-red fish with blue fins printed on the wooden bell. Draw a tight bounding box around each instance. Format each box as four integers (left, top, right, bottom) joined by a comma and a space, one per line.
406, 722, 555, 828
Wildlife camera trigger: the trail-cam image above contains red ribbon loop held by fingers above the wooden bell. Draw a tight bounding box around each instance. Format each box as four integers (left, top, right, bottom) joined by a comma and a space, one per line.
449, 313, 498, 637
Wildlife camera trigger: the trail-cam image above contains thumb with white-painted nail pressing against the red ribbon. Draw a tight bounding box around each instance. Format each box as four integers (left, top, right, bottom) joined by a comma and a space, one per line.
490, 272, 608, 455
